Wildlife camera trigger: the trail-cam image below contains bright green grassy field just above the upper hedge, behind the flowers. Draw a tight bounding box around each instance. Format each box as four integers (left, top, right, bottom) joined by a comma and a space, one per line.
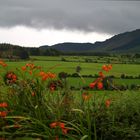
4, 61, 140, 77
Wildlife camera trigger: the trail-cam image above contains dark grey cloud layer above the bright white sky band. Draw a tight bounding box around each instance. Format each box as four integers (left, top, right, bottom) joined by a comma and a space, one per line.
0, 0, 140, 34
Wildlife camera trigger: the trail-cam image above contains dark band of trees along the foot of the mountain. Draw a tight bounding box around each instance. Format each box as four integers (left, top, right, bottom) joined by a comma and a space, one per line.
0, 43, 140, 59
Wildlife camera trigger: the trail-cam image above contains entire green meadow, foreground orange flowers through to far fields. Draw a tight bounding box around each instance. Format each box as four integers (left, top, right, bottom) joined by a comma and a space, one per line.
0, 56, 140, 140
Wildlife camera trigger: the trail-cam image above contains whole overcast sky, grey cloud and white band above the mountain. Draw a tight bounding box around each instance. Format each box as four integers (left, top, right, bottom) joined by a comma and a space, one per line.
0, 0, 140, 47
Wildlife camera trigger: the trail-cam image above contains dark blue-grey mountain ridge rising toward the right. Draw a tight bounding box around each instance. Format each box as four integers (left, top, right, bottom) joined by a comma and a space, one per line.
40, 29, 140, 53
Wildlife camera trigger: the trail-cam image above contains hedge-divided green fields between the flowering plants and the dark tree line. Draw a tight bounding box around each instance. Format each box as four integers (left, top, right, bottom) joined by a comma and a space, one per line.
1, 56, 140, 88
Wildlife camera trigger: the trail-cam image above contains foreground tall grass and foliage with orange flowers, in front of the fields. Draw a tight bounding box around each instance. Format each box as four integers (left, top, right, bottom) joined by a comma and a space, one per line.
0, 61, 140, 140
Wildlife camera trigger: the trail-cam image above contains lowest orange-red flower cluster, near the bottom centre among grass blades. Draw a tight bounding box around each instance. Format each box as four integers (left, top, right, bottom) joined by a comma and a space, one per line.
50, 122, 69, 134
